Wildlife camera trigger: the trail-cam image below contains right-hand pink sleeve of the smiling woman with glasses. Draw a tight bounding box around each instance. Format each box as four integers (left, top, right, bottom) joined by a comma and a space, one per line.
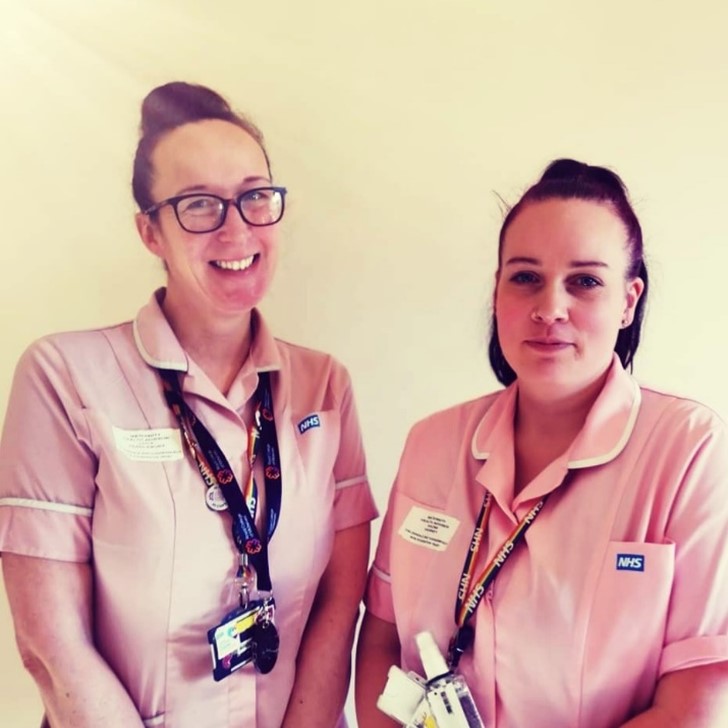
334, 365, 378, 531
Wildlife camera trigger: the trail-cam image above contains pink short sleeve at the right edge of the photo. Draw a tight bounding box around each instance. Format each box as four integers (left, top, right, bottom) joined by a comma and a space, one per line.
660, 416, 728, 675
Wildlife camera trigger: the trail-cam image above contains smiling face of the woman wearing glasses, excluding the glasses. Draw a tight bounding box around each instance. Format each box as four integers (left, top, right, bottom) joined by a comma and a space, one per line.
137, 119, 278, 328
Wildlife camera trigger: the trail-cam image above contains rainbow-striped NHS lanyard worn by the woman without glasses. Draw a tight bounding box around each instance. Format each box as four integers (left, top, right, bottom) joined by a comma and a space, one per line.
448, 478, 565, 670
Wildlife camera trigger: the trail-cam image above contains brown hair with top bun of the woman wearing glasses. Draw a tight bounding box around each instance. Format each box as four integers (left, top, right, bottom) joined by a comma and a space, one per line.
131, 81, 270, 211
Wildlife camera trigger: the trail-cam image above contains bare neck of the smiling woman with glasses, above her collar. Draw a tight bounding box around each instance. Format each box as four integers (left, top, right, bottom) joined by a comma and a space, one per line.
162, 293, 252, 394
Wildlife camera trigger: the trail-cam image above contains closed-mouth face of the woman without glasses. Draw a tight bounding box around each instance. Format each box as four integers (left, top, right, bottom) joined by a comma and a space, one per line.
495, 198, 643, 399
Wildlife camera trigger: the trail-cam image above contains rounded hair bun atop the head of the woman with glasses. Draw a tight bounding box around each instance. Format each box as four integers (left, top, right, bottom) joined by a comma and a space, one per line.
141, 81, 234, 136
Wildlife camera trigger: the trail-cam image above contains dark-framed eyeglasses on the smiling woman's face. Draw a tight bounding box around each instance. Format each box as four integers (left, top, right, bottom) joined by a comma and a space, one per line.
144, 187, 287, 233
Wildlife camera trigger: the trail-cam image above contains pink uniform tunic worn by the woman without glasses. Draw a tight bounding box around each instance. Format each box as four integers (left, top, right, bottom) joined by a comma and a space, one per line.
367, 357, 728, 728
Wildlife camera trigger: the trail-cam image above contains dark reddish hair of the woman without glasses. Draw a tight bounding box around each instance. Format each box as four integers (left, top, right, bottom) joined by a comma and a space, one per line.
488, 159, 648, 386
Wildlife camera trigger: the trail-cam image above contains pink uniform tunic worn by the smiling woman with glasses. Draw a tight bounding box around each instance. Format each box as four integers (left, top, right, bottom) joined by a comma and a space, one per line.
0, 293, 376, 728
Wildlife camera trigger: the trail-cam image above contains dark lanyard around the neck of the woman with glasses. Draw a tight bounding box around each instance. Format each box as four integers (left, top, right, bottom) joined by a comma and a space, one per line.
159, 369, 282, 592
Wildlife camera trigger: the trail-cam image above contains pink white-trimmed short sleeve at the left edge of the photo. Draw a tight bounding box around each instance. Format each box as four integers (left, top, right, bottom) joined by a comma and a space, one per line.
0, 338, 96, 562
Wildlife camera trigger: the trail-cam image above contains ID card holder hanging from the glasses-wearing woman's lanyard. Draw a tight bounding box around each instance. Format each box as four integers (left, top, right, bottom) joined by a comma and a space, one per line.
207, 601, 261, 682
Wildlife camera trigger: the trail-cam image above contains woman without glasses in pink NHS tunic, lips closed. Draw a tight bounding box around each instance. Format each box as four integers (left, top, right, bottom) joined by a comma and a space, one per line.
357, 160, 728, 728
